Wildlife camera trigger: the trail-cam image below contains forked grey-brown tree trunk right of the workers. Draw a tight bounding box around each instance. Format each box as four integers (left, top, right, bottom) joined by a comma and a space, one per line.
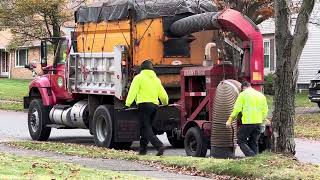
272, 0, 315, 154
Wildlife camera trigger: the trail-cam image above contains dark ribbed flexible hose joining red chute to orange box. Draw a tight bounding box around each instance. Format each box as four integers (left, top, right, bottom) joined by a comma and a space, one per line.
170, 12, 220, 37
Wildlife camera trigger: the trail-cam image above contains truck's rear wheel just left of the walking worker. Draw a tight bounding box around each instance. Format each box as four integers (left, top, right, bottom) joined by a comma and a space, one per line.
92, 105, 113, 148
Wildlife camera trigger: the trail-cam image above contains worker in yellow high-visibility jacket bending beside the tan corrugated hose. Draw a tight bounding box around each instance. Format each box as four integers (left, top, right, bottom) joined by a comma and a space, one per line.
226, 81, 268, 156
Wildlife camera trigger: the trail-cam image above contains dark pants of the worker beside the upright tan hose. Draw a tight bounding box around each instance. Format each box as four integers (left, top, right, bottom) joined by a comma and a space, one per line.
238, 124, 261, 156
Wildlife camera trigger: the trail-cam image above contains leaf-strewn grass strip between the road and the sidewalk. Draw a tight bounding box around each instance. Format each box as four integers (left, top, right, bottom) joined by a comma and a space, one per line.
7, 141, 320, 179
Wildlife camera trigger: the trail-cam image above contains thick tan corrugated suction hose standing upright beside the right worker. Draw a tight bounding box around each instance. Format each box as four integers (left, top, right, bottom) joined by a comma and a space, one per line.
211, 80, 241, 157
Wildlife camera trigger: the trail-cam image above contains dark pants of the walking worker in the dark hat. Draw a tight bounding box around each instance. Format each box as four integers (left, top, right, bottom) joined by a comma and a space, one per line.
138, 103, 163, 150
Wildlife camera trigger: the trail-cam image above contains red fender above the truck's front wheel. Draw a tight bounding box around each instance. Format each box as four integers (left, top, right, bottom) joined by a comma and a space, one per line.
29, 77, 57, 106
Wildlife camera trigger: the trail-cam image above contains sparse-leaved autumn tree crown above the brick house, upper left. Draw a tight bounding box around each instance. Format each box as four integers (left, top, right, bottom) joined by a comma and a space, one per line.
0, 0, 84, 48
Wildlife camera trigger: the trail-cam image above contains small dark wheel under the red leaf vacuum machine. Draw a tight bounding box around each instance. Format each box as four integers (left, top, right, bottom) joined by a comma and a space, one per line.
184, 127, 208, 157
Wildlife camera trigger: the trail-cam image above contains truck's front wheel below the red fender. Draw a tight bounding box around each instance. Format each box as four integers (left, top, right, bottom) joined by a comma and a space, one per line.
28, 99, 51, 141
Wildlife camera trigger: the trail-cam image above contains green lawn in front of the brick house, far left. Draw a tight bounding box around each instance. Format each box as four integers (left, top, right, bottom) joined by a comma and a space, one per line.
0, 79, 30, 102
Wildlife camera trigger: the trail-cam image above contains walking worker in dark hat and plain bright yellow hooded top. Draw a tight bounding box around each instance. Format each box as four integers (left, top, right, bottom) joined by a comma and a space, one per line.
126, 60, 169, 156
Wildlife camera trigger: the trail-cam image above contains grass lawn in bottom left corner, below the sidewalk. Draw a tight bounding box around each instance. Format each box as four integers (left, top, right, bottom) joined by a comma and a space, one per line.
0, 153, 146, 179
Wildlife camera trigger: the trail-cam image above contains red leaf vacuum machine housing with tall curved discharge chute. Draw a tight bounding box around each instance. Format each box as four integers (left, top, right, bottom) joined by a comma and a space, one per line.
178, 9, 264, 141
